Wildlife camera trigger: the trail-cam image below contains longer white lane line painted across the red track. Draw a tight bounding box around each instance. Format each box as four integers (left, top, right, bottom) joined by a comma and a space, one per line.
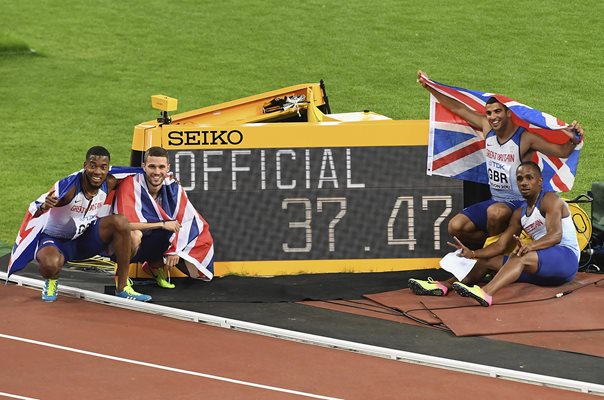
0, 333, 343, 400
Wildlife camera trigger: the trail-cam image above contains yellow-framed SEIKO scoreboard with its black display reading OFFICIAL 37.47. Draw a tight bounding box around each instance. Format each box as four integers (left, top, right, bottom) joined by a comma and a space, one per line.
133, 120, 464, 276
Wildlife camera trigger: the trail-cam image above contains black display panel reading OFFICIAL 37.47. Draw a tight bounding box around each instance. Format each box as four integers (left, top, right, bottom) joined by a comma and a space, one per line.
169, 146, 463, 261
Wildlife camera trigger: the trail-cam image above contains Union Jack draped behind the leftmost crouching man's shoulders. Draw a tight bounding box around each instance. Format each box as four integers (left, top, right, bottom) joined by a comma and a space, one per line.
7, 167, 142, 276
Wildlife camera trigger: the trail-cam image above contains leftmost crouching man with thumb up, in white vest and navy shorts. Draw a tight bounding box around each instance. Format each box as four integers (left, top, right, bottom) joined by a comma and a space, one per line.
9, 146, 151, 302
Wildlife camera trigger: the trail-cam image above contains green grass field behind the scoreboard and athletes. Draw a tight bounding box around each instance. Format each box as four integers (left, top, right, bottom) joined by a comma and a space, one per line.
0, 0, 604, 243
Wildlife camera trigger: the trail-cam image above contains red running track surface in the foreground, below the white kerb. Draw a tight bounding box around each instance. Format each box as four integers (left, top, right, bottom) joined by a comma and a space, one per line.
0, 285, 592, 400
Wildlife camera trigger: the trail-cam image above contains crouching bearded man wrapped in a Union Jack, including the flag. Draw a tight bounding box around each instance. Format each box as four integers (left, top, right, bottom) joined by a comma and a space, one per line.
114, 147, 214, 289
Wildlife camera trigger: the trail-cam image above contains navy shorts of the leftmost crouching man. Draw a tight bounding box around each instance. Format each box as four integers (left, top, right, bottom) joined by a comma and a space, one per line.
37, 220, 109, 262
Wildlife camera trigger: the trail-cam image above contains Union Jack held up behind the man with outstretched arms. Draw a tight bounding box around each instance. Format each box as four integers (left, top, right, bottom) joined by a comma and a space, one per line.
419, 75, 583, 192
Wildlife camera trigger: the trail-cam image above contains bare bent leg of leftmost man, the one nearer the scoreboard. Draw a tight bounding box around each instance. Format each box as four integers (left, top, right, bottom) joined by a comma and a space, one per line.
98, 215, 132, 292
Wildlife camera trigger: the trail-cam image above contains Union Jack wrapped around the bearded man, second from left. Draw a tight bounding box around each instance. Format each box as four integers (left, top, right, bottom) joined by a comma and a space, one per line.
113, 173, 214, 280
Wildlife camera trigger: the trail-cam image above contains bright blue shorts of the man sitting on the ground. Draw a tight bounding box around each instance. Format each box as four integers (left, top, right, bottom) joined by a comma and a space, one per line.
503, 245, 579, 286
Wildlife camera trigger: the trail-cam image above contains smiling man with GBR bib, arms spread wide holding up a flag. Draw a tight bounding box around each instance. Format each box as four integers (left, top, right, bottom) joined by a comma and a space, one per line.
418, 71, 583, 247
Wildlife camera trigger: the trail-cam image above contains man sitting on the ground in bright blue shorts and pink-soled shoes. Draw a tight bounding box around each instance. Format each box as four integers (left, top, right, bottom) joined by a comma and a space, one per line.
409, 161, 580, 307
